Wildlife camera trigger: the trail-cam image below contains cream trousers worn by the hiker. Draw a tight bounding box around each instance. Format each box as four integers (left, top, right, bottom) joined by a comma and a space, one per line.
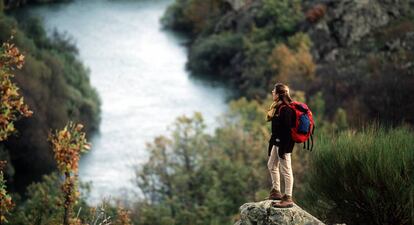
267, 145, 293, 196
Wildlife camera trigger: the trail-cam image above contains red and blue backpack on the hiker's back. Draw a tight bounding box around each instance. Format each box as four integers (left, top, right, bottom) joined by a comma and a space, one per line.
280, 102, 315, 151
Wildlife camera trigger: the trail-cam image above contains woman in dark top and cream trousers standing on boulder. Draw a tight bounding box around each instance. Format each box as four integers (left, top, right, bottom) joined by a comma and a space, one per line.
267, 83, 296, 208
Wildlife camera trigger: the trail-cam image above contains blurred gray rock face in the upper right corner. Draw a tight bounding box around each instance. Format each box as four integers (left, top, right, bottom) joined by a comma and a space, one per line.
305, 0, 414, 47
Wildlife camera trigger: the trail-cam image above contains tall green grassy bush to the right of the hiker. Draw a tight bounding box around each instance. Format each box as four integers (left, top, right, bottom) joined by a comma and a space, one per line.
305, 126, 414, 225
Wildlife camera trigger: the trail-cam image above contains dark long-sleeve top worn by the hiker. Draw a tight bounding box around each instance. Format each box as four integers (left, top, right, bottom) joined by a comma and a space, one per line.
268, 104, 296, 158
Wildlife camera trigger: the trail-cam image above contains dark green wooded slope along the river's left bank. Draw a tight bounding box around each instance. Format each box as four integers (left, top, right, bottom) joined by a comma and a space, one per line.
0, 9, 100, 193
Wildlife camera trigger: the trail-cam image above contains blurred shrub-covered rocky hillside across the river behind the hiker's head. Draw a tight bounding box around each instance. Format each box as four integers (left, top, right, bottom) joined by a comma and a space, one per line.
163, 0, 414, 125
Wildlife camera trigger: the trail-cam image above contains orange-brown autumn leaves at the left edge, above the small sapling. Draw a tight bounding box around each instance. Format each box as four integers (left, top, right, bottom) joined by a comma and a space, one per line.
0, 38, 33, 141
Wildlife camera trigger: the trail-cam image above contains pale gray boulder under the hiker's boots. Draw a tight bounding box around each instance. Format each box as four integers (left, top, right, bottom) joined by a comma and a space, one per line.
235, 200, 323, 225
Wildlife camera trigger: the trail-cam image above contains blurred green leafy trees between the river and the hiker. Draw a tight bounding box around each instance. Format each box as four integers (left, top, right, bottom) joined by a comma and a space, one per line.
134, 99, 269, 225
